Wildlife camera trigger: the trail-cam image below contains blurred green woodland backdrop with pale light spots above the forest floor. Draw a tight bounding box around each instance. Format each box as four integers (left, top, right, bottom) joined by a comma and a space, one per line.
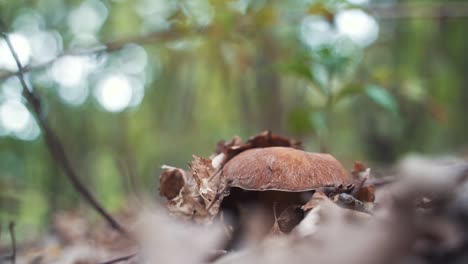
0, 0, 468, 237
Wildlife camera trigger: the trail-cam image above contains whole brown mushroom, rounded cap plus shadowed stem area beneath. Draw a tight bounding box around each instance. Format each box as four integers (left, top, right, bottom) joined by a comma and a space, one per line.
221, 147, 352, 247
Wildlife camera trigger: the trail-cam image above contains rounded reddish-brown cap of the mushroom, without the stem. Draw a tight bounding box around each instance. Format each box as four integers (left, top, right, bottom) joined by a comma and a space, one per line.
222, 147, 351, 192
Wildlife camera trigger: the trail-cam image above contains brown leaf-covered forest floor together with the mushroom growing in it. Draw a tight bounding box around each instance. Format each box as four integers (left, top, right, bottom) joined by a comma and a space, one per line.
8, 131, 468, 264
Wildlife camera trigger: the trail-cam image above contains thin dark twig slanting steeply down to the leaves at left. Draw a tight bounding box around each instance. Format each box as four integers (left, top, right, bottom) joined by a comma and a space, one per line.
2, 27, 128, 237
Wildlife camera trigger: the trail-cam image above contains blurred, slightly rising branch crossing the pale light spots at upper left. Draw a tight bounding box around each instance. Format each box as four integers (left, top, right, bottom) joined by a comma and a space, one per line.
0, 27, 187, 81
